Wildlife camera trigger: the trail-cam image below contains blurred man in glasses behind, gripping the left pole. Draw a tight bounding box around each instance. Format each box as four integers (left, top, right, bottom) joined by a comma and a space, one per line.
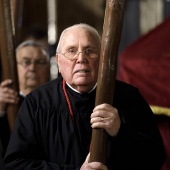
0, 40, 50, 155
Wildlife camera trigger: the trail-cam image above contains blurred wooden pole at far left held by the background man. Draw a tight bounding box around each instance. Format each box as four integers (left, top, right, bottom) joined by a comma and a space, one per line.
0, 0, 19, 131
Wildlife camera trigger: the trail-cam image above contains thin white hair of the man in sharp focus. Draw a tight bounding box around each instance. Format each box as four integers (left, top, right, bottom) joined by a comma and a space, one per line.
56, 23, 101, 53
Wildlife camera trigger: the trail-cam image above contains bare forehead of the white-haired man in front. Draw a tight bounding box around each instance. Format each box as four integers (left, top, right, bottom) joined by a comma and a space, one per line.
60, 27, 100, 49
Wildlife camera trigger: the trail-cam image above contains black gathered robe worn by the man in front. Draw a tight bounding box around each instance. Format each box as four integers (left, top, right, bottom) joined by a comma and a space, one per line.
5, 77, 165, 170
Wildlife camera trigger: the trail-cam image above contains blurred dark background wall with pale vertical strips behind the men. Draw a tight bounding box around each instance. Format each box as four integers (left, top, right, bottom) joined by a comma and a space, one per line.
12, 0, 170, 78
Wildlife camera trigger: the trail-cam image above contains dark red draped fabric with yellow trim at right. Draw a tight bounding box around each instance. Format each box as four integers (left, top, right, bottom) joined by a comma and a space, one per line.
118, 17, 170, 170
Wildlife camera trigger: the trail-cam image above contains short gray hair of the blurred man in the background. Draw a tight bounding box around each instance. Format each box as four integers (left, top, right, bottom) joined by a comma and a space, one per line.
15, 40, 50, 60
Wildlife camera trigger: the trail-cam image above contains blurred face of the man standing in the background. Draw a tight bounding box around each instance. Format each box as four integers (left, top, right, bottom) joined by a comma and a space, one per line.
17, 46, 50, 94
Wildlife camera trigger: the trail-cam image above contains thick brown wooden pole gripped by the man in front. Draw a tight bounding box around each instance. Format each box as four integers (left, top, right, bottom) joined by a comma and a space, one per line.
90, 0, 125, 164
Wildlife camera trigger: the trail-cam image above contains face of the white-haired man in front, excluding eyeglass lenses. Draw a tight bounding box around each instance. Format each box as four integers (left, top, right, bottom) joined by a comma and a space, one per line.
56, 28, 100, 93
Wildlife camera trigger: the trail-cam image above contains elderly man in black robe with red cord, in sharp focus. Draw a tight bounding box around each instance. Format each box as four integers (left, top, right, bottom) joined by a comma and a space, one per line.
5, 24, 165, 170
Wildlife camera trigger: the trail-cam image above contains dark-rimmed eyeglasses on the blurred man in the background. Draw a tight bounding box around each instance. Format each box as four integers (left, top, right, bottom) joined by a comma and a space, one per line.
17, 60, 47, 68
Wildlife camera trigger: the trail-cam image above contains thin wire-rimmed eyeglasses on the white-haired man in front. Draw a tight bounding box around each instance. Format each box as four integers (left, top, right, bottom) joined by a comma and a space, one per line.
58, 48, 98, 60
